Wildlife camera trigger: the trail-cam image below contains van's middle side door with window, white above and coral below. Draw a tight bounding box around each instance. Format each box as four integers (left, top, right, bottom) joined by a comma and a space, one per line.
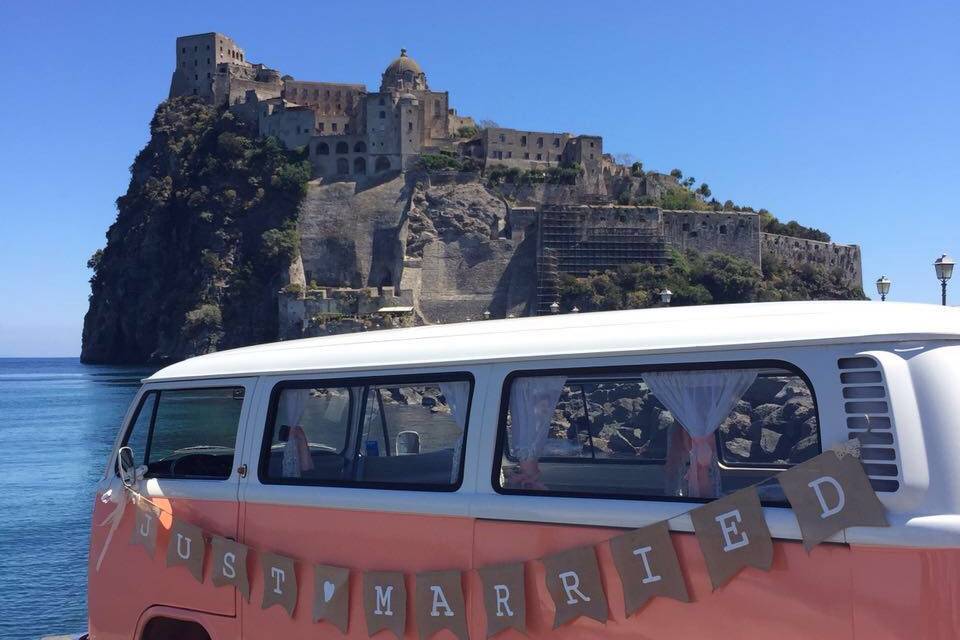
240, 368, 484, 640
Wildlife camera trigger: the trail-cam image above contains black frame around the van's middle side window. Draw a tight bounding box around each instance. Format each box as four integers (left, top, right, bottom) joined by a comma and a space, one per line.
257, 371, 476, 493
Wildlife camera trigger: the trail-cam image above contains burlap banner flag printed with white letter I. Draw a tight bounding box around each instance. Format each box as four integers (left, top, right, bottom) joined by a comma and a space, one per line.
610, 521, 690, 616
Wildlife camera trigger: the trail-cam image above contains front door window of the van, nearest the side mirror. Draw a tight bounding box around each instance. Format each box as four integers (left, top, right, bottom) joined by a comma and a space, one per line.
125, 387, 244, 480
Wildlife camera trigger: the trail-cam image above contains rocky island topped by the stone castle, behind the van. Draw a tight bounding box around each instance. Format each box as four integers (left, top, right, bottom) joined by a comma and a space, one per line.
81, 33, 863, 364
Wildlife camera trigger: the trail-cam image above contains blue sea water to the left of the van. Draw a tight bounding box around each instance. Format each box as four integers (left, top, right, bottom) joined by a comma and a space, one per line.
0, 358, 153, 640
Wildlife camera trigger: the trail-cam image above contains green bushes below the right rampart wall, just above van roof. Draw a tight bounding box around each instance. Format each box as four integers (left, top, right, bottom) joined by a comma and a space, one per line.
560, 251, 865, 311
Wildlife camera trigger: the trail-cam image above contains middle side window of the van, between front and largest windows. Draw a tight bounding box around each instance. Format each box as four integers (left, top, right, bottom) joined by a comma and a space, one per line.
260, 375, 472, 491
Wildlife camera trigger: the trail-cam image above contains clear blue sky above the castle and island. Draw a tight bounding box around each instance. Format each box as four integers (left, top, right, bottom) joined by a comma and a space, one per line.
0, 0, 960, 356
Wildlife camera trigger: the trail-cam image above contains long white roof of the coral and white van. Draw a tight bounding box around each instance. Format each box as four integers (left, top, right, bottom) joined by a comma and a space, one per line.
147, 302, 960, 382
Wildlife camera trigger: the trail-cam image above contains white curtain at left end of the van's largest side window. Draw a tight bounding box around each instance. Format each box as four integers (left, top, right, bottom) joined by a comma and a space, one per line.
510, 376, 567, 462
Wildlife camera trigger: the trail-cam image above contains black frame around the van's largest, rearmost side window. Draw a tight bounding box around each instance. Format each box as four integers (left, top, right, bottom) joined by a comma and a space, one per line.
490, 359, 823, 507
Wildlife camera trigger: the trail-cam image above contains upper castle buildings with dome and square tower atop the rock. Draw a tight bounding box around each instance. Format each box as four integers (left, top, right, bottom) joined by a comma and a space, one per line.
170, 33, 603, 182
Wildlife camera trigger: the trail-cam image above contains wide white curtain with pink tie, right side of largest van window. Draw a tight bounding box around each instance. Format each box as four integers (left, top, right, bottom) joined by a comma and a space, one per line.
643, 369, 757, 498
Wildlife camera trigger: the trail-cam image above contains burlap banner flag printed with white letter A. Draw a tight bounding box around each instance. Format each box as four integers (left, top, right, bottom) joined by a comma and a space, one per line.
413, 571, 468, 640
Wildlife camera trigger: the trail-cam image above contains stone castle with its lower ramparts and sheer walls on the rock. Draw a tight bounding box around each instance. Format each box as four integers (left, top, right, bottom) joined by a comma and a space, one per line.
170, 33, 862, 330
